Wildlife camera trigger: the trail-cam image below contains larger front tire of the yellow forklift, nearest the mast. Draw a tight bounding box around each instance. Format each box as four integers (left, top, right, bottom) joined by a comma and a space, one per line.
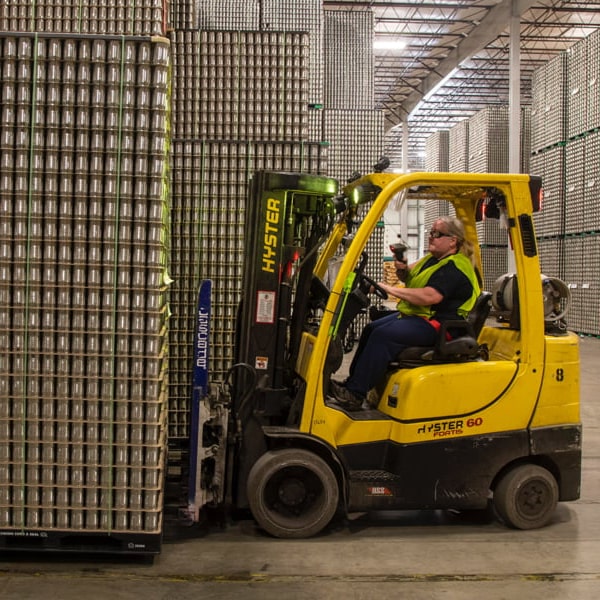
248, 448, 339, 538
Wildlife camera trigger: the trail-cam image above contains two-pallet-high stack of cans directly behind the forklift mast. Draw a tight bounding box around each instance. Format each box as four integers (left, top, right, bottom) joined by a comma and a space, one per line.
169, 14, 325, 444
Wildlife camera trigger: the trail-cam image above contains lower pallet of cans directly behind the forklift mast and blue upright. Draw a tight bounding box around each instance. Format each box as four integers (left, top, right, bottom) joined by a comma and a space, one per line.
169, 139, 327, 442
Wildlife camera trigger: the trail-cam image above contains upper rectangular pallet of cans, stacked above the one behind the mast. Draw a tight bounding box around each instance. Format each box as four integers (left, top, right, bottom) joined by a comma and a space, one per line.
170, 30, 308, 140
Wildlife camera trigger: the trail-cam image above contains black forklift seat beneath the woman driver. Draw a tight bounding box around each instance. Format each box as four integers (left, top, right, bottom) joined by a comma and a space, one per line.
390, 292, 492, 370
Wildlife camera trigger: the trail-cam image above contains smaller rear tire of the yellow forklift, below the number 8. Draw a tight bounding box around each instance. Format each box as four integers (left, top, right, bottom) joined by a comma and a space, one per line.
493, 465, 558, 529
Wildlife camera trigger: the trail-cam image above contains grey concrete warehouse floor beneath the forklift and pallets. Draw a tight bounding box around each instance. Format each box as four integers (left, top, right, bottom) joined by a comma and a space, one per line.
0, 338, 600, 600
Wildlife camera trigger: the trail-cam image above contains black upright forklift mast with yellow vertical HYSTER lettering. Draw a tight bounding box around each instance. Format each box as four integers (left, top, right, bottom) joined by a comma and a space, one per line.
231, 171, 338, 506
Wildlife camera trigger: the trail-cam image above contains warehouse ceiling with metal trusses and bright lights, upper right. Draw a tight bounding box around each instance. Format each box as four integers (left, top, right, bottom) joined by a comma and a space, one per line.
323, 0, 600, 170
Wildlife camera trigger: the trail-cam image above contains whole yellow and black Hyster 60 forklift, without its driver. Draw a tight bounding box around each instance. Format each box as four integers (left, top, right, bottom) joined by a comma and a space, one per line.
183, 163, 582, 538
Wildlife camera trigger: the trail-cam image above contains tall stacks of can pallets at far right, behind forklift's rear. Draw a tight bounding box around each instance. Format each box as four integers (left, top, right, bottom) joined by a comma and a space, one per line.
531, 31, 600, 336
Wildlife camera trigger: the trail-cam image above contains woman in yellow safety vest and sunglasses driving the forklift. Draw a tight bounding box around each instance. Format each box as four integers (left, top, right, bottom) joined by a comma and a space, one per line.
330, 216, 480, 410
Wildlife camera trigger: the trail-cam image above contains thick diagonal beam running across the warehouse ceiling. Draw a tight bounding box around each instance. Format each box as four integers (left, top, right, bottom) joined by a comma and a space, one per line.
386, 0, 537, 127
